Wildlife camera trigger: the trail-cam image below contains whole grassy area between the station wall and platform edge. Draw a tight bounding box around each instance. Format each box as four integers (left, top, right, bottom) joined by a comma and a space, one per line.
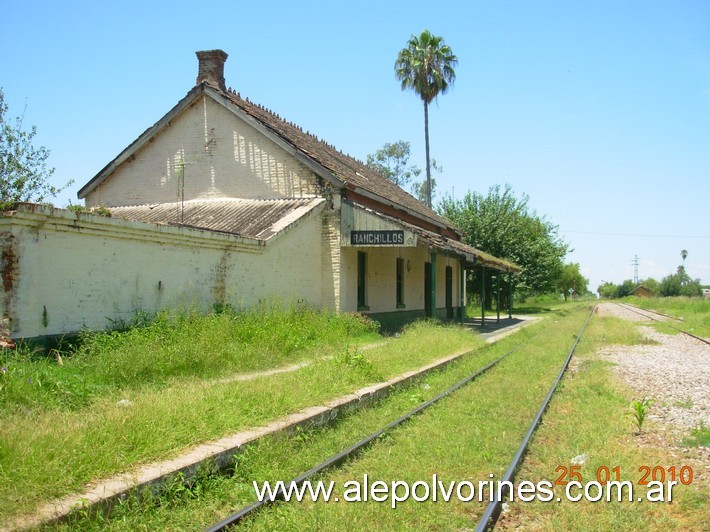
0, 309, 482, 518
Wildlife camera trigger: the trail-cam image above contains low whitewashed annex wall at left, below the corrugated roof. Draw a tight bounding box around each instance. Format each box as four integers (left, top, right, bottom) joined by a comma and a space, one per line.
0, 206, 322, 338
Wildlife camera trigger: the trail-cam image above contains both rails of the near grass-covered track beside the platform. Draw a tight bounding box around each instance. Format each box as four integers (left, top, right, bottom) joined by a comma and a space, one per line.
207, 307, 596, 532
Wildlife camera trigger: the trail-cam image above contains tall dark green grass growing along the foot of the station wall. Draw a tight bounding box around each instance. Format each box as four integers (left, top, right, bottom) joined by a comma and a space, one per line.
0, 305, 379, 413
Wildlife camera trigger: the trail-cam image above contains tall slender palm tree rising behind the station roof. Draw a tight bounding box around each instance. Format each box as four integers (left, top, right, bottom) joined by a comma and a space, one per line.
394, 30, 458, 208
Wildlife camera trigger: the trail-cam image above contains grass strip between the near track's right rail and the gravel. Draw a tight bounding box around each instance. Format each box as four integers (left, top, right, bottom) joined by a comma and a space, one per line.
500, 312, 708, 530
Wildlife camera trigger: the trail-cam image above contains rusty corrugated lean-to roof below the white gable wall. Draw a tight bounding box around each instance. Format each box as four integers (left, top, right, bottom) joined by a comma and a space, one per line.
110, 198, 325, 240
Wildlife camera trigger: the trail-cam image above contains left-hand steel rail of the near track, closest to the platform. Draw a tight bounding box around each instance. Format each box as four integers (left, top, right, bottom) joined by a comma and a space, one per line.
207, 343, 524, 532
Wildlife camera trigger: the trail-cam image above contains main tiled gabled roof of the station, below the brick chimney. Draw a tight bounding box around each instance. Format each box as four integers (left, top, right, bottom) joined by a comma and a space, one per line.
78, 82, 460, 233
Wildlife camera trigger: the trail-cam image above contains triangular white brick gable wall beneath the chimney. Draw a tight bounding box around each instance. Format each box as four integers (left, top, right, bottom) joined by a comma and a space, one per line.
86, 95, 319, 207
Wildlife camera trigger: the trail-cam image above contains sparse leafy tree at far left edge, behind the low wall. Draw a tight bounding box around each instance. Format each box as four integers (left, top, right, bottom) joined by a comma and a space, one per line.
0, 89, 72, 209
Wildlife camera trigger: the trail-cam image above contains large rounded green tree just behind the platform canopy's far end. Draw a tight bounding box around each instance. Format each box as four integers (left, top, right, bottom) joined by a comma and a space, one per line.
437, 185, 568, 308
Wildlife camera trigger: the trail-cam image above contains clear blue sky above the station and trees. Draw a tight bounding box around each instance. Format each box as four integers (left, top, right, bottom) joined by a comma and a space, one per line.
0, 0, 710, 289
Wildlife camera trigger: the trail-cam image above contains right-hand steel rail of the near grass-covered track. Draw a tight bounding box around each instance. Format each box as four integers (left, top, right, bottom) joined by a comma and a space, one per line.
476, 305, 596, 532
